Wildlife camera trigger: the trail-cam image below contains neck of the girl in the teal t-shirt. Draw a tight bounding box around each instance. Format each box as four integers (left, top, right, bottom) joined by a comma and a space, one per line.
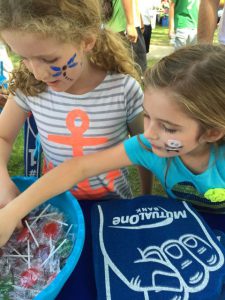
180, 144, 210, 174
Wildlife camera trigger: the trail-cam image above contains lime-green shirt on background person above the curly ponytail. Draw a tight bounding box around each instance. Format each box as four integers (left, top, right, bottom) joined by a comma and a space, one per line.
106, 0, 127, 32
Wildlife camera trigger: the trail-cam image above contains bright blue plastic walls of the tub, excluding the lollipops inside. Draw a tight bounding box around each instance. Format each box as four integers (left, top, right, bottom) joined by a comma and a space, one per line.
13, 177, 85, 300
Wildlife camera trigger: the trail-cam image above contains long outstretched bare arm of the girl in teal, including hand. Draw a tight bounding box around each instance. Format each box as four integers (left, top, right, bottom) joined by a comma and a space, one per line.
0, 144, 132, 247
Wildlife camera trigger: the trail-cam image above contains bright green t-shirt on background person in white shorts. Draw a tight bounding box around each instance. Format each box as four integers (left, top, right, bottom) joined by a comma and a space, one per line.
172, 0, 199, 29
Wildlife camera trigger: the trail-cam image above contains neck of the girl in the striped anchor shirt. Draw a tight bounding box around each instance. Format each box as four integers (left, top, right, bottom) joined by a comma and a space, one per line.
67, 61, 106, 95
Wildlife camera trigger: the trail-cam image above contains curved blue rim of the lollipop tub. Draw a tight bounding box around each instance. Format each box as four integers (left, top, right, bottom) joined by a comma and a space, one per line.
12, 176, 85, 300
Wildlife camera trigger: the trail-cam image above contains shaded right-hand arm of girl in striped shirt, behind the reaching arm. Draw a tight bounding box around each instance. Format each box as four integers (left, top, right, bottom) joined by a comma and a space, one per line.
129, 112, 153, 195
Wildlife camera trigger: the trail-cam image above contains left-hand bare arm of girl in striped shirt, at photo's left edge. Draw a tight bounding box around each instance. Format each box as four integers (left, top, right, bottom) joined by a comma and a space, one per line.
0, 96, 27, 207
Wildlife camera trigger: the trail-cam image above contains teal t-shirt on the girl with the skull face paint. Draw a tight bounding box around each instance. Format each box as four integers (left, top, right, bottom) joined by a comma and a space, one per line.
124, 135, 225, 212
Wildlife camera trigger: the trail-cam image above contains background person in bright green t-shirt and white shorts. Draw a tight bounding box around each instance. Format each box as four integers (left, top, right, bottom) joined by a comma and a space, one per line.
169, 0, 199, 49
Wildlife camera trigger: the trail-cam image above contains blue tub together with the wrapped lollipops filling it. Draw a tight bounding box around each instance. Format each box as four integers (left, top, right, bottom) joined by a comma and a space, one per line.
0, 177, 84, 300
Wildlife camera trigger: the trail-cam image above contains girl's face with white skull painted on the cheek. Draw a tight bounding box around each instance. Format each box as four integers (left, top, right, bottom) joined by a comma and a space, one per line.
144, 89, 205, 157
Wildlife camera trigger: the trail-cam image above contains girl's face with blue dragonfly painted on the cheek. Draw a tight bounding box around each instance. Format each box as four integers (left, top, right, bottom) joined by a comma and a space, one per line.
2, 30, 87, 92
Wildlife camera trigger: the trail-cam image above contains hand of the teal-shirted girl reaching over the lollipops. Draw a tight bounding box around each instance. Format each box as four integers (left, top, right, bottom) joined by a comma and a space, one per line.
0, 205, 20, 248
